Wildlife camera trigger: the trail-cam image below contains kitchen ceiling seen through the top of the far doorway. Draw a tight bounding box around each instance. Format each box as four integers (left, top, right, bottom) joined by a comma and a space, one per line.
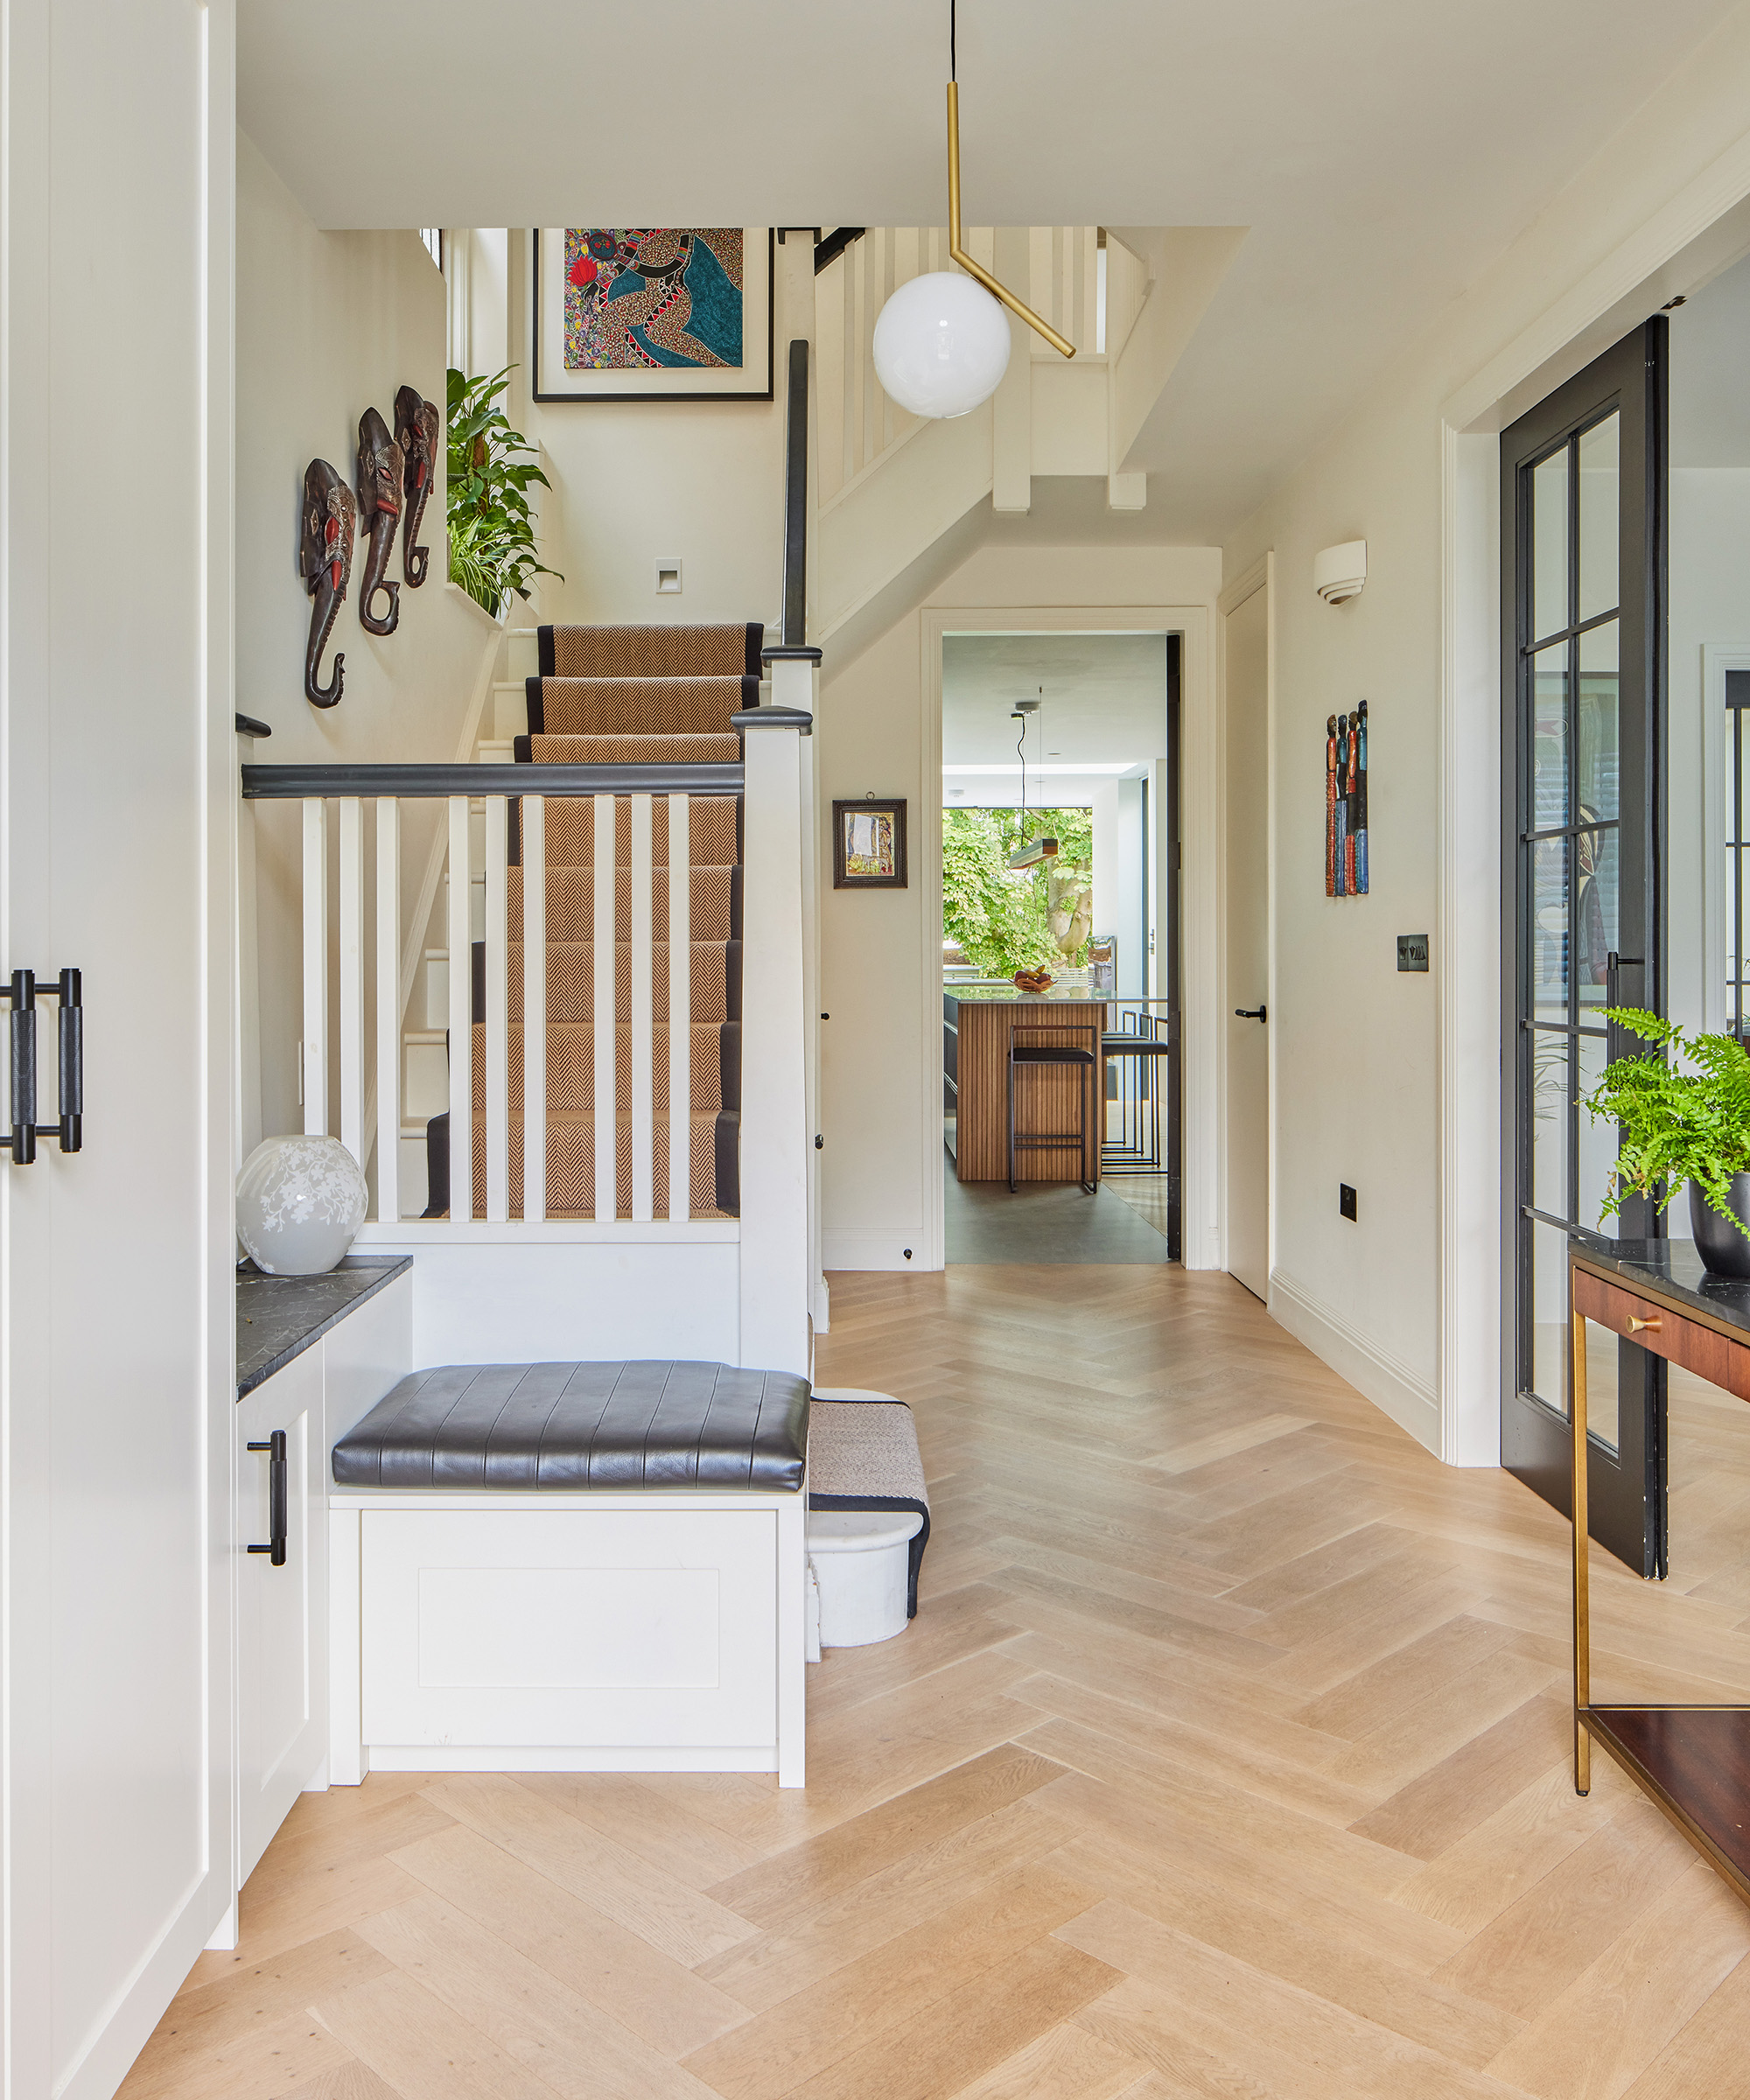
942, 634, 1166, 780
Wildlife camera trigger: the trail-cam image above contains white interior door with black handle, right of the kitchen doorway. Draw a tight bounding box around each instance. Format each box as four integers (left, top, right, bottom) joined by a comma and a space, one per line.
1222, 578, 1269, 1298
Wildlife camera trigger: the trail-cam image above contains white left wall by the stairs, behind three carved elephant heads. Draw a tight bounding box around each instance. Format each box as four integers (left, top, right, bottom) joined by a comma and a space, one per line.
237, 132, 498, 1146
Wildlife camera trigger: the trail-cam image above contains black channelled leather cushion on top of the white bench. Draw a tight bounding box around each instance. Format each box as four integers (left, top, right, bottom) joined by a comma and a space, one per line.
334, 1363, 808, 1491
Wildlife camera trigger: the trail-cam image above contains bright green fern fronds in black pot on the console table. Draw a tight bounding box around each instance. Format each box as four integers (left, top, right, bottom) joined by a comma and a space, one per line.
1582, 1006, 1750, 1239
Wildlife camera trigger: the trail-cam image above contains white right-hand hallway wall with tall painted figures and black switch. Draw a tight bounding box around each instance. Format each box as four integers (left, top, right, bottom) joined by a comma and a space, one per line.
1225, 9, 1750, 1461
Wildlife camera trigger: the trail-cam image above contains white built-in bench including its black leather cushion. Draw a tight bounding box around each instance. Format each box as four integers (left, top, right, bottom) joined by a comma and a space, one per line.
330, 1363, 808, 1787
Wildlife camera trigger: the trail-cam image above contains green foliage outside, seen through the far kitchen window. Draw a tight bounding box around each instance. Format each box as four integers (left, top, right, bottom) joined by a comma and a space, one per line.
942, 808, 1095, 976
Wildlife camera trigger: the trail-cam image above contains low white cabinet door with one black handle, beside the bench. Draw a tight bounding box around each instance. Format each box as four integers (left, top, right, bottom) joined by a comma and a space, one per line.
237, 1348, 328, 1886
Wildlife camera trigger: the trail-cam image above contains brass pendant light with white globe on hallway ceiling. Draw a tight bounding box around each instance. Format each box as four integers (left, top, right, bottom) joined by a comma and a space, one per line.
874, 0, 1075, 418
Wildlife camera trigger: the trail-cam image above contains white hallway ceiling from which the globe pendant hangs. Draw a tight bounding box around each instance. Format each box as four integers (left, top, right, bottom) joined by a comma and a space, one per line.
237, 0, 1731, 542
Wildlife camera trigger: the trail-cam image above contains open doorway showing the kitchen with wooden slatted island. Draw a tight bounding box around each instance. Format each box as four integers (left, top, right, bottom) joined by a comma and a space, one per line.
942, 632, 1180, 1262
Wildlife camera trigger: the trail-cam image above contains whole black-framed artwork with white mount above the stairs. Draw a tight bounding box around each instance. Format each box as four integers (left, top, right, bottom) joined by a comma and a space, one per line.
534, 227, 774, 401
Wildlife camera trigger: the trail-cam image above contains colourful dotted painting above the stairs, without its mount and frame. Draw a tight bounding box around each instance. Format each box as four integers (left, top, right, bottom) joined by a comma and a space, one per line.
565, 227, 742, 372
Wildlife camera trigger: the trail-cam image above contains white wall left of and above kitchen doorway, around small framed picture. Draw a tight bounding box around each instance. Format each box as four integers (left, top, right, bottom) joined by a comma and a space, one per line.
816, 544, 1221, 1269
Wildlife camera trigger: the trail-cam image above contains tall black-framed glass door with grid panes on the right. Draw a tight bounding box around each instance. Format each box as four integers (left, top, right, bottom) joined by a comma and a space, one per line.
1500, 315, 1666, 1575
